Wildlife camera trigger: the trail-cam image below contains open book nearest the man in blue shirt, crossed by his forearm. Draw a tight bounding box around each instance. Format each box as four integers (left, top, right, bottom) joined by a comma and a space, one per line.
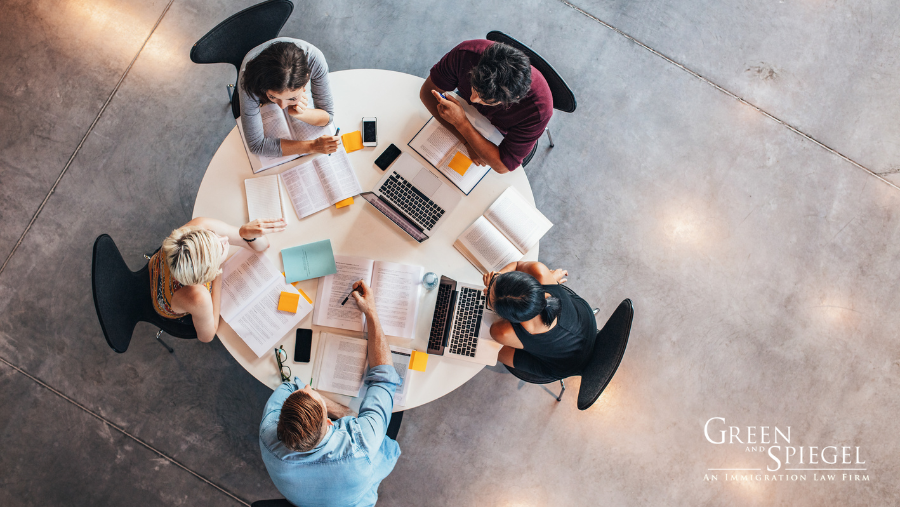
313, 333, 412, 407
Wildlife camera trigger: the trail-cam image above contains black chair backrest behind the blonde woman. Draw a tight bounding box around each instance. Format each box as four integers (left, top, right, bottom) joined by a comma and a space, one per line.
91, 234, 150, 353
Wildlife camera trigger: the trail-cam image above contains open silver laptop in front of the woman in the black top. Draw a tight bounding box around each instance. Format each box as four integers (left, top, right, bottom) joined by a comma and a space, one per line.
428, 276, 503, 365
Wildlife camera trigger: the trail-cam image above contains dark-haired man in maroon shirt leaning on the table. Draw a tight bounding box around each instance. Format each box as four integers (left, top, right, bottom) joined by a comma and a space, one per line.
419, 40, 553, 173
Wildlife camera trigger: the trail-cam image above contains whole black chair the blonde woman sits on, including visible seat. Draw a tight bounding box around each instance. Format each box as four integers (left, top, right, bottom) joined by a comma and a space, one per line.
91, 234, 197, 353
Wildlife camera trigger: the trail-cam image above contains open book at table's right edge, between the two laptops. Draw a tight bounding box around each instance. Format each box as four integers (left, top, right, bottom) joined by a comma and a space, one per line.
453, 187, 553, 273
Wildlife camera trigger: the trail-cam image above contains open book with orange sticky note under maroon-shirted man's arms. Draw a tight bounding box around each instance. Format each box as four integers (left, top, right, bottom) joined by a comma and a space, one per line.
409, 99, 503, 195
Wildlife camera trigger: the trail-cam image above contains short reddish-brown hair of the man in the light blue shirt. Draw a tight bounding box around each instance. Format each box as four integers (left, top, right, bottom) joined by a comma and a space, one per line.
278, 391, 326, 452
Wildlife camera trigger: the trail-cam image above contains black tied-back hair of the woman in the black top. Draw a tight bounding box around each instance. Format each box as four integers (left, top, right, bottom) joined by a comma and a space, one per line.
488, 271, 562, 326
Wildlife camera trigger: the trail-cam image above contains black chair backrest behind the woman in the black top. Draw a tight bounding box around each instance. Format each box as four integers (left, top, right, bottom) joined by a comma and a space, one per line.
578, 299, 634, 410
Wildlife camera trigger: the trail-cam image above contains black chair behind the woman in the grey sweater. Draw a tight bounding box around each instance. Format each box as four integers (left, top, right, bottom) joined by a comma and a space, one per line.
191, 0, 294, 118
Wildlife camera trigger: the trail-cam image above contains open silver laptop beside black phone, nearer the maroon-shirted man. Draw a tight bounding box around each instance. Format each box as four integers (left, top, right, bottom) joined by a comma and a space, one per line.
360, 153, 462, 243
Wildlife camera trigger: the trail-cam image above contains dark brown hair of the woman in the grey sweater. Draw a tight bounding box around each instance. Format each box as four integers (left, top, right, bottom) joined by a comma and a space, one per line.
241, 42, 309, 104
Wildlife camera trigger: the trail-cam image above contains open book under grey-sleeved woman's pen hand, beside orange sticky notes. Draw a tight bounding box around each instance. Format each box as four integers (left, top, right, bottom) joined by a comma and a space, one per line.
281, 147, 362, 218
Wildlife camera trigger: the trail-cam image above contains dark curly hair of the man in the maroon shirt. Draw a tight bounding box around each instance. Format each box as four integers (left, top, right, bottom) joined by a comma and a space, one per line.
471, 42, 531, 106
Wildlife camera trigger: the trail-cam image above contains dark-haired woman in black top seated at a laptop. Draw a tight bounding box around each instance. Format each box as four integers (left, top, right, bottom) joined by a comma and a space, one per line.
484, 262, 597, 379
